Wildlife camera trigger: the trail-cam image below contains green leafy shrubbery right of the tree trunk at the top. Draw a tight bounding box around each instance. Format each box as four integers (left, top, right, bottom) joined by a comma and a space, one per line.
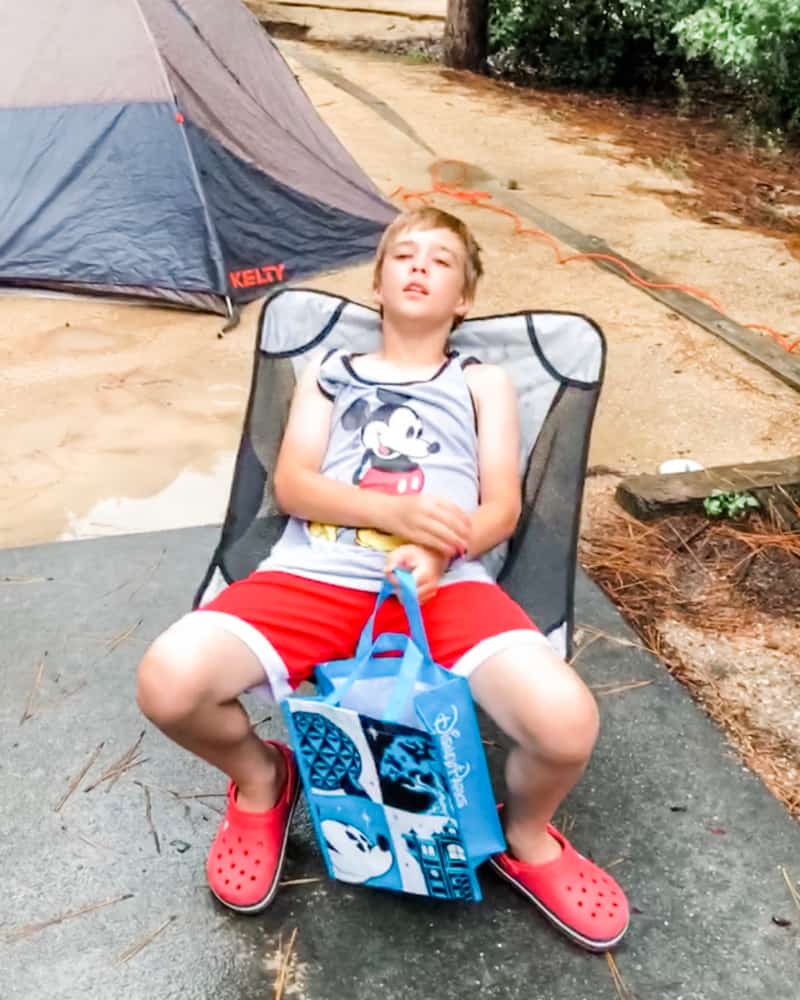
489, 0, 800, 131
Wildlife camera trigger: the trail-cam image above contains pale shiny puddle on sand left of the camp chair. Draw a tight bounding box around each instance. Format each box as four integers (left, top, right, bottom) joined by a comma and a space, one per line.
58, 451, 236, 542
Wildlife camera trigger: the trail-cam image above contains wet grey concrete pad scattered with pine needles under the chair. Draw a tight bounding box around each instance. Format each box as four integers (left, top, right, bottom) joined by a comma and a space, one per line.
0, 527, 800, 1000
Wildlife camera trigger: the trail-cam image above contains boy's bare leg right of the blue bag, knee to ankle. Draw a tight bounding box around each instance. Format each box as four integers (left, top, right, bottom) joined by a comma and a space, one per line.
470, 640, 598, 864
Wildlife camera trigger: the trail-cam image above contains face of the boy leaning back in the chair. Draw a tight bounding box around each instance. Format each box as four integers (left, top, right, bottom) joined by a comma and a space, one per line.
375, 229, 471, 325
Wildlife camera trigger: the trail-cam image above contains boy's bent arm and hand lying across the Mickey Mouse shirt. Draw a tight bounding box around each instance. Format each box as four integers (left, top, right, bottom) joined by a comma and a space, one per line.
273, 357, 469, 555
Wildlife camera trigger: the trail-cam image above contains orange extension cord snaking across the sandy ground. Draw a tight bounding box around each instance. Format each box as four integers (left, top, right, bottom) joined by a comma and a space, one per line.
390, 160, 800, 354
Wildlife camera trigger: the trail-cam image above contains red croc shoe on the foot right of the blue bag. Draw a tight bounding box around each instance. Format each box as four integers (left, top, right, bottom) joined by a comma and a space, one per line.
490, 824, 629, 951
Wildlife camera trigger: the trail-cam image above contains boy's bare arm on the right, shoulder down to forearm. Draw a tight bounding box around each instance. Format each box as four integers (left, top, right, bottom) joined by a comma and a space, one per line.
464, 365, 522, 559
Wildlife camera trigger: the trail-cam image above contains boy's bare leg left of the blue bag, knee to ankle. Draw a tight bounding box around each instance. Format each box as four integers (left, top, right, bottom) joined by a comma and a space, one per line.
136, 617, 286, 812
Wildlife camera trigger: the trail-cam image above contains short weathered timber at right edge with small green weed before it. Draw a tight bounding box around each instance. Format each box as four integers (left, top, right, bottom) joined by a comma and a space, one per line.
616, 456, 800, 531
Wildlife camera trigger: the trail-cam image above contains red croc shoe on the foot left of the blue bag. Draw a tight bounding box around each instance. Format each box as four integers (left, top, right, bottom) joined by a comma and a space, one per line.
206, 740, 300, 913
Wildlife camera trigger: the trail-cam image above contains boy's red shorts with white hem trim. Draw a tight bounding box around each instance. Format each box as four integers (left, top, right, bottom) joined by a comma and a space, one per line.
195, 571, 546, 700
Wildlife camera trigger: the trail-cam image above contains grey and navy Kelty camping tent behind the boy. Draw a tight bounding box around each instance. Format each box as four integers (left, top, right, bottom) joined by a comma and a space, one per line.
0, 0, 394, 312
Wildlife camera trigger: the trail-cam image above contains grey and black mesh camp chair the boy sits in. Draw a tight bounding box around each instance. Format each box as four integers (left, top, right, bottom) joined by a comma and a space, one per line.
195, 288, 605, 656
